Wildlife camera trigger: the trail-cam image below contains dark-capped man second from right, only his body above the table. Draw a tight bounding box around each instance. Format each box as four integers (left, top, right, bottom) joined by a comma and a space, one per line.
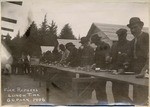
110, 28, 130, 69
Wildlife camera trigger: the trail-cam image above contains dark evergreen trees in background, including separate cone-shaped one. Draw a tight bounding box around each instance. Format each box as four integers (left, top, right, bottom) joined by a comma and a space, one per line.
5, 15, 76, 57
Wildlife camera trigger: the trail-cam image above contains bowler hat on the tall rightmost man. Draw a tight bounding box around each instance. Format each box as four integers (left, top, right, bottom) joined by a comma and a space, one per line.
127, 17, 144, 28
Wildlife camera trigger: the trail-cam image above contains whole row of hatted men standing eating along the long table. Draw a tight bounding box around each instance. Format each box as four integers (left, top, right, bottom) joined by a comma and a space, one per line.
9, 17, 149, 105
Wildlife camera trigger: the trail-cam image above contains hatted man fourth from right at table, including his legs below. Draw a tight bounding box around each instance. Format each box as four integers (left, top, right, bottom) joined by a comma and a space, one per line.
78, 37, 94, 100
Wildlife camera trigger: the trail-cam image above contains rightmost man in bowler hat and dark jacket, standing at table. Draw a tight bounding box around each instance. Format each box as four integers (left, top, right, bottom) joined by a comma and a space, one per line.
127, 17, 149, 105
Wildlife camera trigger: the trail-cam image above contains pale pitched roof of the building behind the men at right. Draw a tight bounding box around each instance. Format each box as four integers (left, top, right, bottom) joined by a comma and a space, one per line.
87, 23, 148, 41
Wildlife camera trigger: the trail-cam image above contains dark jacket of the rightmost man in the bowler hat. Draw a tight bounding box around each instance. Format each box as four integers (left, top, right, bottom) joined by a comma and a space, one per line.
130, 32, 149, 73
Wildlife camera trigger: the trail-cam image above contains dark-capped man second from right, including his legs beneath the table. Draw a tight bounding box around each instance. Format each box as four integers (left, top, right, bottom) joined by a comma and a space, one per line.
110, 28, 131, 103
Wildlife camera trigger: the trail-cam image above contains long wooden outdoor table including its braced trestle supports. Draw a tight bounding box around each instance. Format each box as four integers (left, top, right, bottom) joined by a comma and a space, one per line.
33, 64, 149, 101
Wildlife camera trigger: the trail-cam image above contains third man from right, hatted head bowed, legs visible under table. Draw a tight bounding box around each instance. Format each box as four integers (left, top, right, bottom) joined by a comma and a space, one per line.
91, 34, 110, 104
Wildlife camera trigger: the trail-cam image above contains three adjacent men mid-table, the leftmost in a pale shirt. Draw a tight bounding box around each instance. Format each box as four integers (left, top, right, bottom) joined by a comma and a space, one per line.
59, 37, 94, 67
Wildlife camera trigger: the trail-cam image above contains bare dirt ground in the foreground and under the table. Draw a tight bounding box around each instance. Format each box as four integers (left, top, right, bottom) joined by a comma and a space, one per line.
2, 75, 133, 105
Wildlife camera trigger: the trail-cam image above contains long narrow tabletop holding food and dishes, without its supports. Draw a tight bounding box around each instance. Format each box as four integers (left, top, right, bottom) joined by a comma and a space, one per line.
40, 64, 149, 87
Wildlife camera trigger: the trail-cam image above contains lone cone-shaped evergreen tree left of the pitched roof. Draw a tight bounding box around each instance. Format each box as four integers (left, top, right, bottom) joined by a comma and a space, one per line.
59, 24, 76, 39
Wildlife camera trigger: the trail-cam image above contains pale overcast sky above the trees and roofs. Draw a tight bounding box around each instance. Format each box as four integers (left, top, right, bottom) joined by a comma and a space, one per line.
1, 0, 149, 38
